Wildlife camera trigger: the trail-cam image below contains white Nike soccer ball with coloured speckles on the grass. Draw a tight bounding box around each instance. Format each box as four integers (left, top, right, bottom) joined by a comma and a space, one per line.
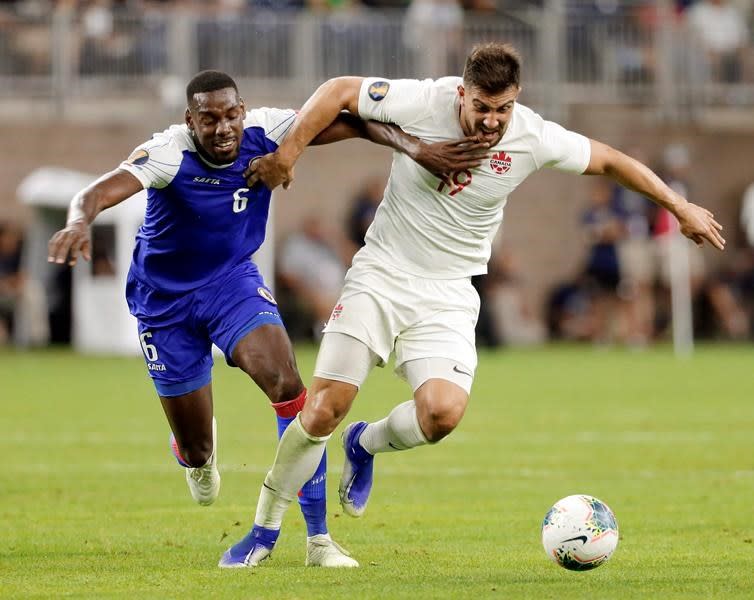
542, 494, 618, 571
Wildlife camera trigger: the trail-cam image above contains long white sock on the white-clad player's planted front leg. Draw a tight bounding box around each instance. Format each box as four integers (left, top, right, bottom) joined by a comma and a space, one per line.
254, 414, 330, 529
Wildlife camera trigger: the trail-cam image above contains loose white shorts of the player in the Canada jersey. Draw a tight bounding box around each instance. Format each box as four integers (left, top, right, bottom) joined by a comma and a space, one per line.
325, 256, 479, 374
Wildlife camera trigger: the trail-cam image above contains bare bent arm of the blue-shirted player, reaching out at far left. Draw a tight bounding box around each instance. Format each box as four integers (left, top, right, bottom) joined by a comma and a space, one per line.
47, 169, 144, 266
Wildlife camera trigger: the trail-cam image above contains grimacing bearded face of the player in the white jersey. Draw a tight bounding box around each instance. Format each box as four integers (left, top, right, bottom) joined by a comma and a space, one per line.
458, 85, 521, 147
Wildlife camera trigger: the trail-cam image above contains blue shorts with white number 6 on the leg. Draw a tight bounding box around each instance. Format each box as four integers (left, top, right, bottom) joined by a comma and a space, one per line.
126, 261, 283, 396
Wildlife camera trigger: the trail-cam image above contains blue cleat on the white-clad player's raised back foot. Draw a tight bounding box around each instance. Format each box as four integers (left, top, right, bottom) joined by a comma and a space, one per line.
338, 421, 374, 517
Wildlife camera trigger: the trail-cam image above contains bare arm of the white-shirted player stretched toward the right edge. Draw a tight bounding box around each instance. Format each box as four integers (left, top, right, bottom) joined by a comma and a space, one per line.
584, 140, 725, 250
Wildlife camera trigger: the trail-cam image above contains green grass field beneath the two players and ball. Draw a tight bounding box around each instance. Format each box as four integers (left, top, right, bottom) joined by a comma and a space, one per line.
0, 346, 754, 600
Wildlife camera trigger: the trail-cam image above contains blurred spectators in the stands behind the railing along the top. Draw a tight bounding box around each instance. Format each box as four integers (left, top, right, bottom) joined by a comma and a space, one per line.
0, 0, 754, 91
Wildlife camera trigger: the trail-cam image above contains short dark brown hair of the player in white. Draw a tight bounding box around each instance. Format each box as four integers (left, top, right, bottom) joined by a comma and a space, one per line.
463, 42, 521, 94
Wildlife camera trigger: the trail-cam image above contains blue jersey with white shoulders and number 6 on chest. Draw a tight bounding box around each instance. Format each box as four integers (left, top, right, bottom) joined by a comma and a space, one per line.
120, 108, 296, 293
